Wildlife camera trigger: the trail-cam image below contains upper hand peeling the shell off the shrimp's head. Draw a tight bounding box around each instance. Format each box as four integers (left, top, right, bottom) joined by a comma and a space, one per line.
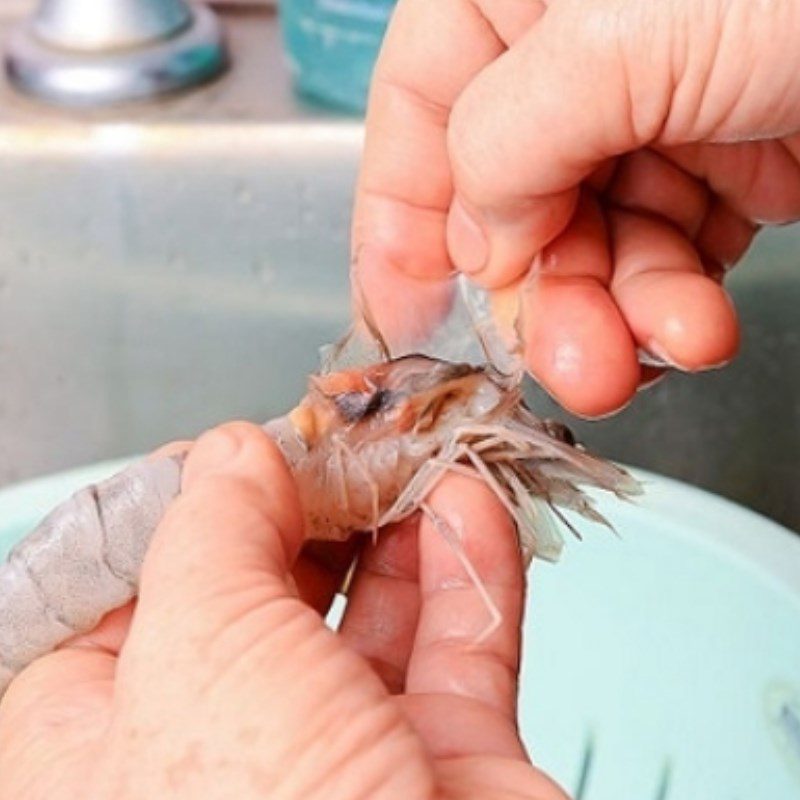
353, 0, 800, 416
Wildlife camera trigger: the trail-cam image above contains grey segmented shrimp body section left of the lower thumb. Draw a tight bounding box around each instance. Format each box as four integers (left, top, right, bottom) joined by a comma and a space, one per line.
0, 454, 185, 696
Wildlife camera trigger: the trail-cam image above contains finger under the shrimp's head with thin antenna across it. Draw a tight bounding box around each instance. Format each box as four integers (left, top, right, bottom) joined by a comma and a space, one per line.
406, 476, 525, 720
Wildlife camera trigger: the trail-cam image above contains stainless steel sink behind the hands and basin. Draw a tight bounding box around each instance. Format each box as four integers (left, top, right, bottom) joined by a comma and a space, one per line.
0, 7, 800, 528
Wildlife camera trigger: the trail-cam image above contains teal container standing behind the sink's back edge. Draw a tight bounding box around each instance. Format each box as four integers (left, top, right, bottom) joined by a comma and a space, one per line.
279, 0, 395, 112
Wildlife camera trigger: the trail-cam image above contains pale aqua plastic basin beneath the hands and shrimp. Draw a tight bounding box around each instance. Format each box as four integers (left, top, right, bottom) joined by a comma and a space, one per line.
0, 462, 800, 800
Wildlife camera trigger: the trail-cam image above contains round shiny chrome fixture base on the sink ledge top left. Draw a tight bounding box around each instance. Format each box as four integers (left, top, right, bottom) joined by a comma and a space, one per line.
6, 0, 226, 107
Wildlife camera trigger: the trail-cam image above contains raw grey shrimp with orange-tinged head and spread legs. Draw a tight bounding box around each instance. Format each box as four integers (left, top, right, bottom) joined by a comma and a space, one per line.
0, 328, 639, 693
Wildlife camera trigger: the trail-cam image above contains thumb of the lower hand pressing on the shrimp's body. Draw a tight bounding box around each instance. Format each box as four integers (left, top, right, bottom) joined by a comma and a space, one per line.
120, 422, 303, 670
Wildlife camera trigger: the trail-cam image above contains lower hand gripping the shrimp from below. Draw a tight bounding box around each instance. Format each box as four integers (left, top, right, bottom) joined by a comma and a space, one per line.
0, 423, 566, 800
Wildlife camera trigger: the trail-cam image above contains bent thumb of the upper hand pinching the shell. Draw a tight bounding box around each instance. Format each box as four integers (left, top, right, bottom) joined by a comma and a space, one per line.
447, 0, 669, 288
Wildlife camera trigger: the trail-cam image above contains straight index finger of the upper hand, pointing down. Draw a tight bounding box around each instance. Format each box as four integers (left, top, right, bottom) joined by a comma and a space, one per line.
352, 0, 542, 340
